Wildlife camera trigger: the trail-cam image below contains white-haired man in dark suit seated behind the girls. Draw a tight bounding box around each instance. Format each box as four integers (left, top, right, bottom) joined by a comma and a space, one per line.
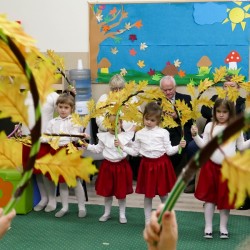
160, 76, 192, 176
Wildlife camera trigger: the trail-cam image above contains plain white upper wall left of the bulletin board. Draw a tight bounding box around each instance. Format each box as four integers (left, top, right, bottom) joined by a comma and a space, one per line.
0, 0, 88, 52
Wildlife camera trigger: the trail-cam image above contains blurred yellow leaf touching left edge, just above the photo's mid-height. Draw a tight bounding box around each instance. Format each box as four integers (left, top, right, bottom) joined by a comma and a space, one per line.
0, 82, 28, 126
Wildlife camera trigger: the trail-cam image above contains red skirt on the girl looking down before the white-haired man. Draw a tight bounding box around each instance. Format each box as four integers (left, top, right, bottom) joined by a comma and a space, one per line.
135, 154, 176, 198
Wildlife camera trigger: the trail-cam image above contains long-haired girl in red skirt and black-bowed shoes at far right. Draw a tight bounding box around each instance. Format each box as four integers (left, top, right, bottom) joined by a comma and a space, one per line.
191, 99, 250, 239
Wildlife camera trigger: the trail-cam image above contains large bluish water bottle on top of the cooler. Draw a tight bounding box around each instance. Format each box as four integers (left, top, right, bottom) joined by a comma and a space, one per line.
69, 59, 91, 102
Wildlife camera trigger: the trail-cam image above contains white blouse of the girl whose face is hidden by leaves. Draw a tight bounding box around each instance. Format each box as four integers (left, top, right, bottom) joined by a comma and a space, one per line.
87, 131, 134, 162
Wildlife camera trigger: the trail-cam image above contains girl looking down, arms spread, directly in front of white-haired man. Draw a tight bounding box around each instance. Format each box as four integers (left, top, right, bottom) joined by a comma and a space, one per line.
116, 102, 186, 224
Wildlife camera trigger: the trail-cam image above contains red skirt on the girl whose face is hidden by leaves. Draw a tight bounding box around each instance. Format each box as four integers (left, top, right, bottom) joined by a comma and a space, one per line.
95, 159, 133, 199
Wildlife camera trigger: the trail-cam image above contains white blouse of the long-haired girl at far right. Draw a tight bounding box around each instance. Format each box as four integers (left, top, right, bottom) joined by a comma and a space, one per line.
194, 122, 250, 164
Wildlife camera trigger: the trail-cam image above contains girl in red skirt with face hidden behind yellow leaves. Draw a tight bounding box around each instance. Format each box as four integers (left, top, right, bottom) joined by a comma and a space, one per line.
86, 116, 134, 224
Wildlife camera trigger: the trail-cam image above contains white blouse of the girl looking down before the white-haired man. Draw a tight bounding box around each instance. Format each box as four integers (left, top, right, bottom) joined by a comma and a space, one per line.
123, 126, 179, 158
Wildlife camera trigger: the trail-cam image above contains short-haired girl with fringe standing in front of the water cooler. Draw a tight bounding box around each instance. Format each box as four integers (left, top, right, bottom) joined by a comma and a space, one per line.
43, 93, 86, 218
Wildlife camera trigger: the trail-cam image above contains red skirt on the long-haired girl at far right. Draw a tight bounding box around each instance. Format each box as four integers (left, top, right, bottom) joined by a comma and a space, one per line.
194, 160, 235, 210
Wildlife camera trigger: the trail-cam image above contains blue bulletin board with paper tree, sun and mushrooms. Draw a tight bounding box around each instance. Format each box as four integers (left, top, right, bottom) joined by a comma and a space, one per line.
89, 1, 250, 85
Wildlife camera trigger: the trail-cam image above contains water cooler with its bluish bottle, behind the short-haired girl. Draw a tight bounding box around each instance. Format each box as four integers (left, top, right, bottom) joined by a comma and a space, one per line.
69, 59, 92, 138
